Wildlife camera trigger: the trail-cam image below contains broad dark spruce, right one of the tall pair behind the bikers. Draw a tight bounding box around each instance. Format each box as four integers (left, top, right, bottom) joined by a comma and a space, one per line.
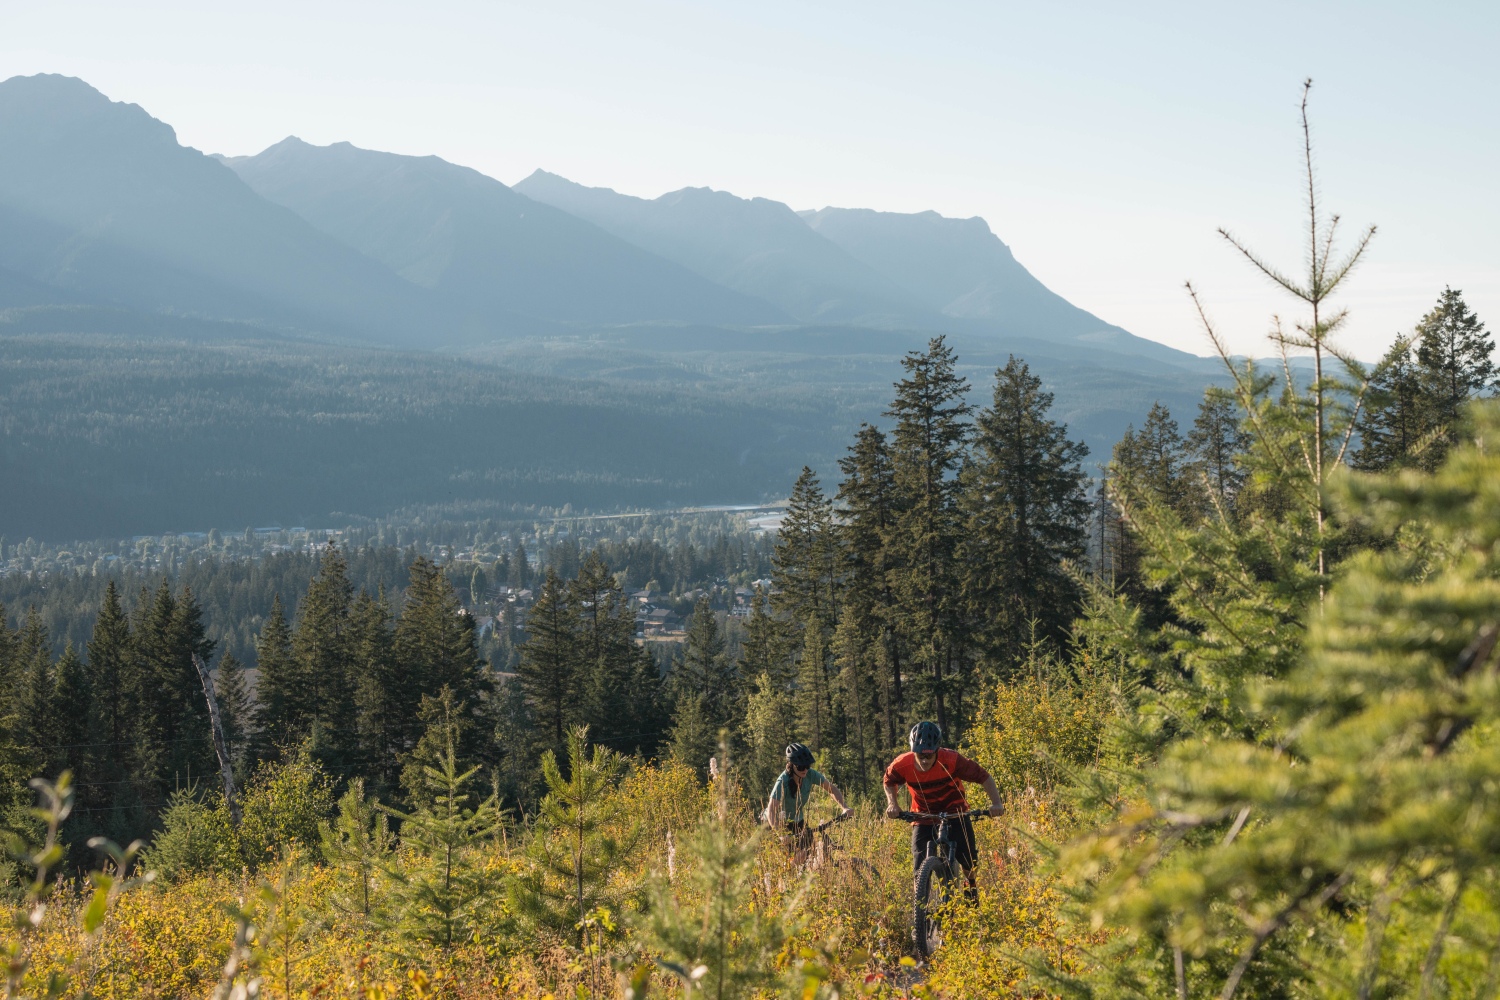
959, 355, 1089, 670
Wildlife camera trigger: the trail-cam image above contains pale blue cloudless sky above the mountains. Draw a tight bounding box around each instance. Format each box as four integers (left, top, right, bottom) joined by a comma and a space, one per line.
0, 0, 1500, 357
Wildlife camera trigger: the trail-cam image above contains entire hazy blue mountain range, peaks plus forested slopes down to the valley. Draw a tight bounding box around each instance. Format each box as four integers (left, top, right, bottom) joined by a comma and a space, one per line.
0, 76, 1211, 540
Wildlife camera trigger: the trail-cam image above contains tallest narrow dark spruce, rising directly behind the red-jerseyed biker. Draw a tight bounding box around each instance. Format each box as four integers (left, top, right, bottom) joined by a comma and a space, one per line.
887, 337, 972, 729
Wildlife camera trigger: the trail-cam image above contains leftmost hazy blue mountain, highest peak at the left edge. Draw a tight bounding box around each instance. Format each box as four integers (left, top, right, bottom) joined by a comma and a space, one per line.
0, 75, 474, 342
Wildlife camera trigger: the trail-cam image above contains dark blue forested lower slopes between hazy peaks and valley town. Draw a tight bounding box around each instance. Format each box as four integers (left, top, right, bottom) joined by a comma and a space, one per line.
0, 322, 1208, 543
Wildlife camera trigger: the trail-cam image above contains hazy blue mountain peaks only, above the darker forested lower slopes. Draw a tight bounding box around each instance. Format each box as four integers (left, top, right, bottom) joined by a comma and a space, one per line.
0, 75, 1188, 360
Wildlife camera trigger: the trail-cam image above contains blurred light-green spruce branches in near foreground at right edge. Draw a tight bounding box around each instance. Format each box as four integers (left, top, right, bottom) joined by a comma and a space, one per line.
1052, 406, 1500, 997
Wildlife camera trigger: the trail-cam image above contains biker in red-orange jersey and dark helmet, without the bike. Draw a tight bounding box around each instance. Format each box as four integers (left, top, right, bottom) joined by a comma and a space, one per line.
884, 723, 1005, 886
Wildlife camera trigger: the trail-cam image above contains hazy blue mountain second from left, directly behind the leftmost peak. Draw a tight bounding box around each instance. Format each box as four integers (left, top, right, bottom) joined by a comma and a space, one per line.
222, 136, 791, 325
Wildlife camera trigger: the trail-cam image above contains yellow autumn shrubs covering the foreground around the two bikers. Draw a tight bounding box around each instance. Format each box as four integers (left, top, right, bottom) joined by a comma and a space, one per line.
6, 758, 1104, 1000
